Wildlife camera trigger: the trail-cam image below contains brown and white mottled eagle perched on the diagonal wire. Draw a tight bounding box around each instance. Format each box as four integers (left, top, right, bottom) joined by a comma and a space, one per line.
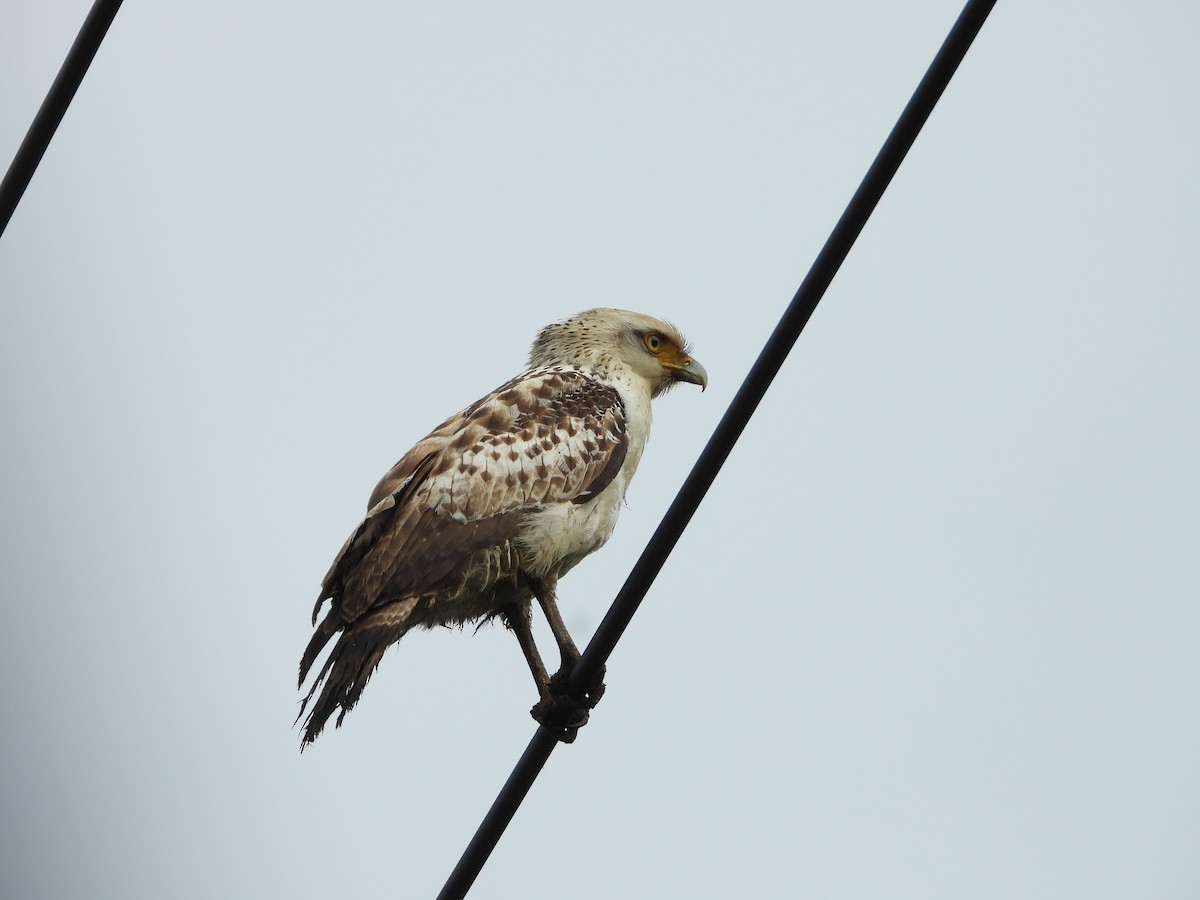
296, 308, 708, 749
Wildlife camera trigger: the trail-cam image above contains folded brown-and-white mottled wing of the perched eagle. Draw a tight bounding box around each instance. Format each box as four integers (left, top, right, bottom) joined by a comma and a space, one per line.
314, 368, 628, 623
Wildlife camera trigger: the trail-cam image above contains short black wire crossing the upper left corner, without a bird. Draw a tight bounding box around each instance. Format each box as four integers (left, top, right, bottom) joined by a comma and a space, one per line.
0, 0, 121, 235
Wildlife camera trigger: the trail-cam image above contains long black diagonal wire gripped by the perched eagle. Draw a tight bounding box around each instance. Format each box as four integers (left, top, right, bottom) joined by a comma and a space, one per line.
438, 0, 996, 900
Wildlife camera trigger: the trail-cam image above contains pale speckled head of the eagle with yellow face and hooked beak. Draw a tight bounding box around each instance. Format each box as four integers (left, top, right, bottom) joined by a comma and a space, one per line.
529, 310, 708, 397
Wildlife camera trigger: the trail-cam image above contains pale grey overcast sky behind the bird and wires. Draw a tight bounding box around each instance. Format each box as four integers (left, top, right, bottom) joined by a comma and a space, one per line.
0, 0, 1200, 900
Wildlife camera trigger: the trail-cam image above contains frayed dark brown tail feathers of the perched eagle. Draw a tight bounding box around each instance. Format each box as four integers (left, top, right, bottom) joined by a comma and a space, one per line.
296, 598, 416, 750
